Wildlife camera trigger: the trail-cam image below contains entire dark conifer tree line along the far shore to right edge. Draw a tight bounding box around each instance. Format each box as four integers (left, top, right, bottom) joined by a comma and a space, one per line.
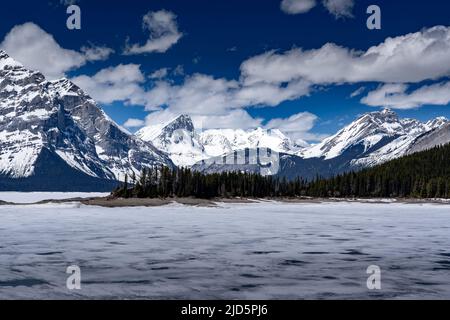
113, 145, 450, 199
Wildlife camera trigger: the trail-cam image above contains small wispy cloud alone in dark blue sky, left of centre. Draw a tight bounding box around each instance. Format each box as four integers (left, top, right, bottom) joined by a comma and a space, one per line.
124, 10, 183, 55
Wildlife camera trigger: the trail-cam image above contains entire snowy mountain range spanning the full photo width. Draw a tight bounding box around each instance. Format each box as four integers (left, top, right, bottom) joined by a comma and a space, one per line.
0, 51, 450, 191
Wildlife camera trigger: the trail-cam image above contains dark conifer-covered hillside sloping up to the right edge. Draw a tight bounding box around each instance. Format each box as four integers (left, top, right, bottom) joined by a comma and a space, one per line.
307, 145, 450, 198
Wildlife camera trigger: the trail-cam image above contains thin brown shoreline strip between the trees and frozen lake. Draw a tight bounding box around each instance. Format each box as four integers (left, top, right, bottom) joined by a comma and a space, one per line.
0, 196, 450, 208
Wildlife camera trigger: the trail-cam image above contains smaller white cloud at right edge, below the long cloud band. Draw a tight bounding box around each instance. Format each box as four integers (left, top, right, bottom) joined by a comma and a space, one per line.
361, 82, 450, 109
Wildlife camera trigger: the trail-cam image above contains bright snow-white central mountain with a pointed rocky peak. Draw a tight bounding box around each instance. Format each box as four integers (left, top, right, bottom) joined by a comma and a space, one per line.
136, 115, 301, 166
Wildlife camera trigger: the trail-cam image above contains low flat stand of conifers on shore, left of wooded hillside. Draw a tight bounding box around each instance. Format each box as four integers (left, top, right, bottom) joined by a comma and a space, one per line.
113, 167, 306, 199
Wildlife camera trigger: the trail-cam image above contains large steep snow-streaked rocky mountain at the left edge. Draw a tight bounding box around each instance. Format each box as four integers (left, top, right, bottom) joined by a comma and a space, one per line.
0, 51, 173, 190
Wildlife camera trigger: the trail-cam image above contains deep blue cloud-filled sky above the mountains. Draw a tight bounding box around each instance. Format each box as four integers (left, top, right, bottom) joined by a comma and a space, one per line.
0, 0, 450, 141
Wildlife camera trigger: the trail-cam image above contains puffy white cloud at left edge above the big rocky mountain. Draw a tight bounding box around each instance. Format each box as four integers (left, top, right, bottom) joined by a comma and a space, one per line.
0, 22, 112, 79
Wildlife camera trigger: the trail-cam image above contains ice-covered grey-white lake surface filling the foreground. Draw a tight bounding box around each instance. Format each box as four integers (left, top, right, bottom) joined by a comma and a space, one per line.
0, 203, 450, 299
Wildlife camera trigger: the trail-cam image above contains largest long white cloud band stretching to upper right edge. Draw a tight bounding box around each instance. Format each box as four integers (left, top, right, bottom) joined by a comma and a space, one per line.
241, 26, 450, 84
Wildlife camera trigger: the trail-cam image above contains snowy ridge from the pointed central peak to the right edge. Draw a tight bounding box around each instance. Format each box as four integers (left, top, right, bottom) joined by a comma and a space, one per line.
137, 109, 448, 170
